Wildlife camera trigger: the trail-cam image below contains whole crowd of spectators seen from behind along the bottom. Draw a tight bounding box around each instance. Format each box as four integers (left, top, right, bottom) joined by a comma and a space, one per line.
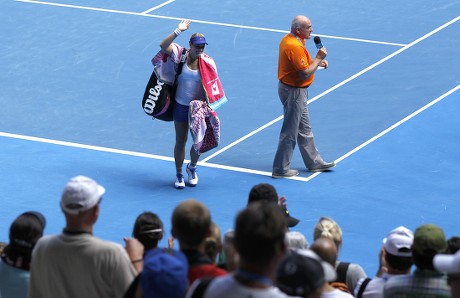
0, 176, 460, 298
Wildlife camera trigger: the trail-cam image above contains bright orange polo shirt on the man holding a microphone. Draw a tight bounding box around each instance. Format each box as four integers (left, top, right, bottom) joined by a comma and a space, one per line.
278, 34, 314, 87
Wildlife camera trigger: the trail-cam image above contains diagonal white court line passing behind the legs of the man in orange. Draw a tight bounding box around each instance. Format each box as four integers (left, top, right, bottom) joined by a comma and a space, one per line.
206, 16, 460, 160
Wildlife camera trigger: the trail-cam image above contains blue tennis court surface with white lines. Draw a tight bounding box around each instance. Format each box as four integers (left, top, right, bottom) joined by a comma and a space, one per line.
0, 0, 460, 276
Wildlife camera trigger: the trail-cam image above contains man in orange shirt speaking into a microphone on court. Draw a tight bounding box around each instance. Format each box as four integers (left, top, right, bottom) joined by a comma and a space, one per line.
272, 15, 335, 178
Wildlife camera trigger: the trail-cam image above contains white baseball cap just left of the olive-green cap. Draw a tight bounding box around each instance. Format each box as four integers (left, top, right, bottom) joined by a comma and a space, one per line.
383, 226, 414, 257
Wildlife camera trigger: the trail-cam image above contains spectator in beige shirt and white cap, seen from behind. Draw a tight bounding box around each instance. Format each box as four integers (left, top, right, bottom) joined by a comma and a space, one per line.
29, 176, 144, 298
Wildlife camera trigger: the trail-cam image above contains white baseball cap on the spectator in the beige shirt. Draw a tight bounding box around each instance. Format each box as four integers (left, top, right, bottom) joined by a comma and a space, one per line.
61, 176, 105, 214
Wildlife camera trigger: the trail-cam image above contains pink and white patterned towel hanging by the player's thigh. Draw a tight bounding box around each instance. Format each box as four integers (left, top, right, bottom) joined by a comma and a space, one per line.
189, 100, 220, 154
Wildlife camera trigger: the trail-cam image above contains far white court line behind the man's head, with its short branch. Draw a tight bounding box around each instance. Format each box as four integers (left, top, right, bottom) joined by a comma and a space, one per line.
15, 0, 405, 46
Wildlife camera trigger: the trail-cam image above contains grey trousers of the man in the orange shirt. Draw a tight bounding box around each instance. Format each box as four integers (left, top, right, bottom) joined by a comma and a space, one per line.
273, 82, 325, 174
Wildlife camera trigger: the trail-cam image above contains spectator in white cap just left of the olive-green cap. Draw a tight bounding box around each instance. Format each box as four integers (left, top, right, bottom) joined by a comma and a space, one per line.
354, 226, 414, 298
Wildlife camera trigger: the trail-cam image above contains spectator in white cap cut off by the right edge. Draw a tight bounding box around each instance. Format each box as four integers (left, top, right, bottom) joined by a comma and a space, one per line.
433, 251, 460, 297
